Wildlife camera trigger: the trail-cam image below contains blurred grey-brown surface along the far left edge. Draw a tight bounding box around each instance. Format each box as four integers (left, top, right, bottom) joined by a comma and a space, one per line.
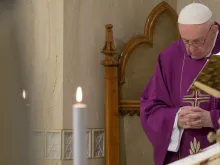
0, 0, 29, 165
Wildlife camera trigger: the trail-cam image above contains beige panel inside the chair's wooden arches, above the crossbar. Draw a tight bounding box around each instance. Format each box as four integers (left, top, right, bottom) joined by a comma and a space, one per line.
122, 13, 178, 100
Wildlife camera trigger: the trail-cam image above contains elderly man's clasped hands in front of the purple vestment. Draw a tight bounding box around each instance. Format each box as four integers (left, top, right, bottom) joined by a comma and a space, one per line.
178, 106, 213, 129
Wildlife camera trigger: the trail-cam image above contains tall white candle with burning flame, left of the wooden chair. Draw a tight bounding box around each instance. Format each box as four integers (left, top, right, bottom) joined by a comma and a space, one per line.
73, 87, 87, 165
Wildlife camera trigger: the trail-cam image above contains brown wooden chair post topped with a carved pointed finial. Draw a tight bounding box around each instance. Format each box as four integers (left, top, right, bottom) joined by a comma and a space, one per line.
101, 25, 119, 165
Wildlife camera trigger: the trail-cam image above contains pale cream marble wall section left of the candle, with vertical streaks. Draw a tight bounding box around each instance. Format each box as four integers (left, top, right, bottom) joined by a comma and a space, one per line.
13, 0, 63, 165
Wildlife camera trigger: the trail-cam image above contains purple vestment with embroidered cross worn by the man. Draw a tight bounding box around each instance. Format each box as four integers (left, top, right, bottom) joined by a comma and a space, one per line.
140, 23, 220, 165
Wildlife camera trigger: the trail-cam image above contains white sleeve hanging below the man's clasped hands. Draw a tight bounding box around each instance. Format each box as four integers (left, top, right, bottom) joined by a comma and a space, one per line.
168, 108, 184, 152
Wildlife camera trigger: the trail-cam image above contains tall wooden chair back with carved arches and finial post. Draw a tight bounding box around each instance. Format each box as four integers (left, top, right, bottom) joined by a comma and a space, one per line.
102, 2, 179, 165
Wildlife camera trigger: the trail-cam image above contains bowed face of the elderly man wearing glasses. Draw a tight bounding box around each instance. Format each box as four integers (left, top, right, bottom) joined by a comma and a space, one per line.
179, 23, 217, 59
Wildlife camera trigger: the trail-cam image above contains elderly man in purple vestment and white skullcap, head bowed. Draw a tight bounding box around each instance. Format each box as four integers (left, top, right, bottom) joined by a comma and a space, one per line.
140, 3, 220, 165
